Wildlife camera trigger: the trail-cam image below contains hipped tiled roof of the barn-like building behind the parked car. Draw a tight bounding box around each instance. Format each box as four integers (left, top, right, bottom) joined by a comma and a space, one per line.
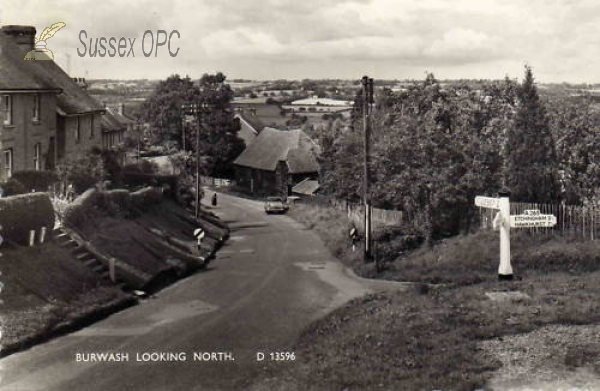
234, 127, 319, 174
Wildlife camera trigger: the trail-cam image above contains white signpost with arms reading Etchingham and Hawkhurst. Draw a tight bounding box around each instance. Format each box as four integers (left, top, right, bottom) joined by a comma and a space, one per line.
475, 193, 556, 280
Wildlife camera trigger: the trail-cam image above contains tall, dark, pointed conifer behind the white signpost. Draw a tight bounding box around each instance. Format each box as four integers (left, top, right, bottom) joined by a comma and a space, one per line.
504, 66, 560, 203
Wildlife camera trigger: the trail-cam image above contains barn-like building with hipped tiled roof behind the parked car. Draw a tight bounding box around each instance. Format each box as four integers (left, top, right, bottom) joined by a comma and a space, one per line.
233, 127, 319, 197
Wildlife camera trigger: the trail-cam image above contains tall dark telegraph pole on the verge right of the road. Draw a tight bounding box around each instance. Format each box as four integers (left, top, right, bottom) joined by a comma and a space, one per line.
362, 76, 374, 263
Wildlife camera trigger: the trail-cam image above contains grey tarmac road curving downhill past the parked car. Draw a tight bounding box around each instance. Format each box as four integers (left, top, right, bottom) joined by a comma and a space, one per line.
0, 193, 406, 391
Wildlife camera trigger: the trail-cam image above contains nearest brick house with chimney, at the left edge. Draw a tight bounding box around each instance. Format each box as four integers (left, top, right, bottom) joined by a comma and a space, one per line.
0, 26, 104, 181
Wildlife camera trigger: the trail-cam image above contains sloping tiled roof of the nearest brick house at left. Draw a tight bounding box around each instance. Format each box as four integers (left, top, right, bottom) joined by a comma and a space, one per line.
0, 29, 103, 115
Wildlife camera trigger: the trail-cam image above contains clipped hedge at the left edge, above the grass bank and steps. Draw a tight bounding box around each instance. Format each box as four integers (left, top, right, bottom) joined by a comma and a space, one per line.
0, 193, 55, 244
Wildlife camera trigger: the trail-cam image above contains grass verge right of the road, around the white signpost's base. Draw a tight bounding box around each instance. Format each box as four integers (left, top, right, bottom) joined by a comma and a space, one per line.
248, 206, 600, 391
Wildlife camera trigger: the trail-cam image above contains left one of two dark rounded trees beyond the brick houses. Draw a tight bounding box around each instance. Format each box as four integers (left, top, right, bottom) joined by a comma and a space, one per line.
143, 74, 200, 149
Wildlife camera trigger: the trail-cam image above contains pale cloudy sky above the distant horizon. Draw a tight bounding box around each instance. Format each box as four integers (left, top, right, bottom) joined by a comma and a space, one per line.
0, 0, 600, 83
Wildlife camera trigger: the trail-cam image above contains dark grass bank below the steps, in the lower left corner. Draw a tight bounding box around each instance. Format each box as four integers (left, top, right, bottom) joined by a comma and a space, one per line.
0, 242, 135, 356
